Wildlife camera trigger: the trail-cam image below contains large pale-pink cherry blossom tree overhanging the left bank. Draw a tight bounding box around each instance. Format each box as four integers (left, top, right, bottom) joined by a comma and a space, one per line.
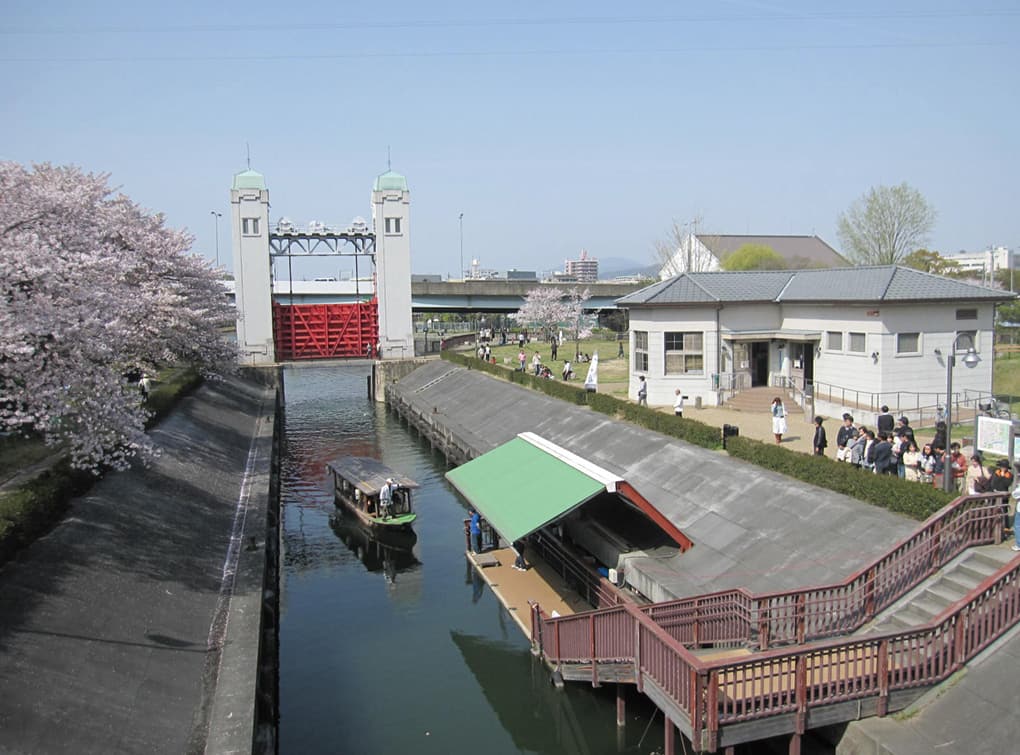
0, 162, 236, 471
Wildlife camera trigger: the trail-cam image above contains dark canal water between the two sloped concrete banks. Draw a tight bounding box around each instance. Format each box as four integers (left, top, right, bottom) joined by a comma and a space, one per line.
279, 364, 663, 755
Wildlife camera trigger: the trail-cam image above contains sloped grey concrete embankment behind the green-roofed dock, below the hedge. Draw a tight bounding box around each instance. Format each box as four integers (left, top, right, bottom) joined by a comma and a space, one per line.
386, 361, 916, 601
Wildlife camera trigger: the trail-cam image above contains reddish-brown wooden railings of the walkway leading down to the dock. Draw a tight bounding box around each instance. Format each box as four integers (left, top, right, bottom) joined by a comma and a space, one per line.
532, 494, 1020, 750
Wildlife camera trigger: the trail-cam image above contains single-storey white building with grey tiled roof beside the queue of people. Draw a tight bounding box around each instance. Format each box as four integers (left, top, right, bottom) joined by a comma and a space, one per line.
617, 265, 1014, 415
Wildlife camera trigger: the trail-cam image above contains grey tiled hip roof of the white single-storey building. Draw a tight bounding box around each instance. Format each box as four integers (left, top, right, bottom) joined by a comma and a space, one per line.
616, 265, 1015, 307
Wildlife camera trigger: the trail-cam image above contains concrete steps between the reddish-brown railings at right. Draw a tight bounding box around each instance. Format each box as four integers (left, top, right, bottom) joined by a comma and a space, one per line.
858, 543, 1016, 635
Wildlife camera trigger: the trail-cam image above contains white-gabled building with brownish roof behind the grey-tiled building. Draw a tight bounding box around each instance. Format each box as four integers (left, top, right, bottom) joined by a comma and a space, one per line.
659, 234, 847, 281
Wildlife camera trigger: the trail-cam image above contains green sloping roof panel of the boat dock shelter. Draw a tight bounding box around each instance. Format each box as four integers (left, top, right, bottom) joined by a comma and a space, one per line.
446, 437, 606, 543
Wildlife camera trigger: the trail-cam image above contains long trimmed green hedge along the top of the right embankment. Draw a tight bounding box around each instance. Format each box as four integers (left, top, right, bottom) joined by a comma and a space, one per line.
443, 351, 955, 519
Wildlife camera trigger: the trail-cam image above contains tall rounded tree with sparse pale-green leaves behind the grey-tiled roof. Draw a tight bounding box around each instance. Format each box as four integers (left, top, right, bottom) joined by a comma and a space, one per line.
836, 183, 936, 265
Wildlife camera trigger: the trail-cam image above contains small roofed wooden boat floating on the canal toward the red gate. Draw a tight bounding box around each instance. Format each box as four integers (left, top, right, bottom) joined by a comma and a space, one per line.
326, 456, 418, 533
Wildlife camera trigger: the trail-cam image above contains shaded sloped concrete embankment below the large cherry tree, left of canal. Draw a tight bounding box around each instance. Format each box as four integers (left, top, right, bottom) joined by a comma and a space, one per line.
0, 380, 278, 753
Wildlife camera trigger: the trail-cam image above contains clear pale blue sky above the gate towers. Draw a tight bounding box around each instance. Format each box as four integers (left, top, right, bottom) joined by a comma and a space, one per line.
0, 0, 1020, 275
